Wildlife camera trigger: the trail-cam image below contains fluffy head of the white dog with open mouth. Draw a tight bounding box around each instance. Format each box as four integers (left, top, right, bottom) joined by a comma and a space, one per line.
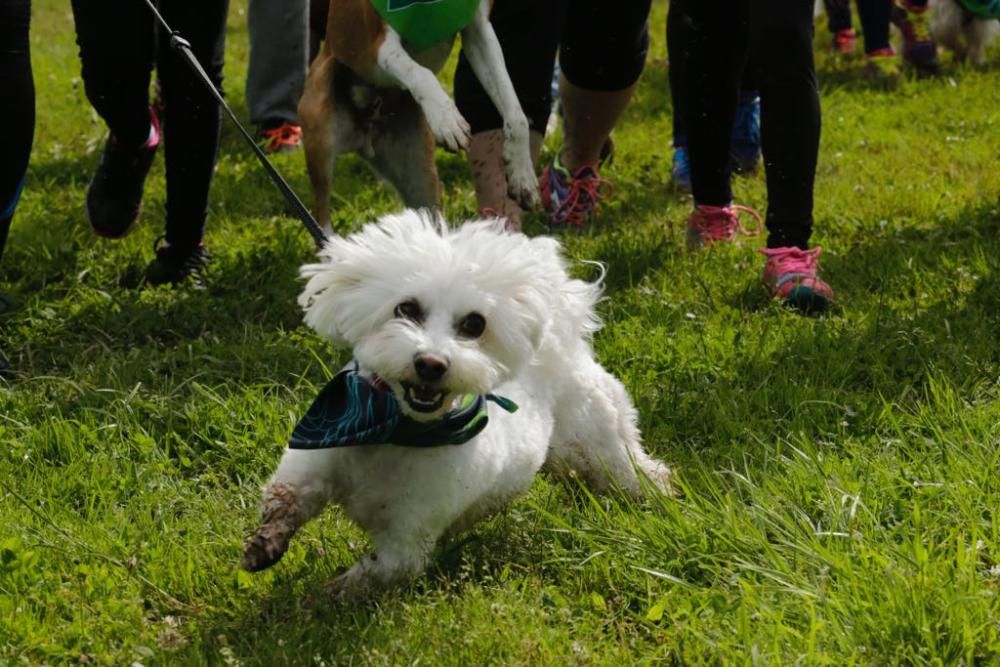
300, 211, 580, 420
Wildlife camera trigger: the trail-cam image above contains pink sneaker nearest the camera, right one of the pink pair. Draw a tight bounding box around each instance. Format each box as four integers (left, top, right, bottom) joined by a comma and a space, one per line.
760, 248, 833, 312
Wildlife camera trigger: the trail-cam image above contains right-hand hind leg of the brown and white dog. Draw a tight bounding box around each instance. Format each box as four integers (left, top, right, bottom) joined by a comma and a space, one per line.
368, 95, 441, 209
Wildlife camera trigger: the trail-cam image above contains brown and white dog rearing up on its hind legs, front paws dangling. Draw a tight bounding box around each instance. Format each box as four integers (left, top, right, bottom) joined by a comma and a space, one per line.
299, 0, 539, 233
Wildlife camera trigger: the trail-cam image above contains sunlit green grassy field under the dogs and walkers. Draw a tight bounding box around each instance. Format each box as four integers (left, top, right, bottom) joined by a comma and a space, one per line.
0, 0, 1000, 665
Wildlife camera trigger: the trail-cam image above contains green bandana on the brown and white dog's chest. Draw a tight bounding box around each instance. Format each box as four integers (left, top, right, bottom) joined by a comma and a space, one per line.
371, 0, 479, 51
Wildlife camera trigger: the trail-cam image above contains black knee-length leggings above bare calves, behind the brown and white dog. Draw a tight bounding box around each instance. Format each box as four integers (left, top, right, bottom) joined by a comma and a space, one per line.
455, 0, 650, 133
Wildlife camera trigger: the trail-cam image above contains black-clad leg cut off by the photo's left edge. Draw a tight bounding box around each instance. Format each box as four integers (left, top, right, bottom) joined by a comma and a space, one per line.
0, 0, 35, 264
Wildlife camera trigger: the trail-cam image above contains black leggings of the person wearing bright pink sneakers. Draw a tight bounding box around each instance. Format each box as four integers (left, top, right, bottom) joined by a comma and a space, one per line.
667, 0, 820, 248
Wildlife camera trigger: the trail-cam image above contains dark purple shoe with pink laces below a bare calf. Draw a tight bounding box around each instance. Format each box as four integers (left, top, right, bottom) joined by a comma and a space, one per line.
538, 156, 611, 232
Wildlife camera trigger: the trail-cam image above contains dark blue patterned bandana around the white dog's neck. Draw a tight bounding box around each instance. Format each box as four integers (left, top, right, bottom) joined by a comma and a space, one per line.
288, 361, 517, 449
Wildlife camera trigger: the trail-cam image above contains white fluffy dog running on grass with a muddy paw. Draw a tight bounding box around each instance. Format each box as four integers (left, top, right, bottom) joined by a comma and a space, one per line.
242, 211, 670, 592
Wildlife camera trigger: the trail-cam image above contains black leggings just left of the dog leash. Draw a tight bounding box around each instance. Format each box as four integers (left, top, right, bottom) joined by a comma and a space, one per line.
72, 0, 229, 246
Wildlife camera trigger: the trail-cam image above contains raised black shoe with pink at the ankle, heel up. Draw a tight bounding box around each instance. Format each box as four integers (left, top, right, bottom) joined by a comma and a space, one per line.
87, 107, 160, 239
